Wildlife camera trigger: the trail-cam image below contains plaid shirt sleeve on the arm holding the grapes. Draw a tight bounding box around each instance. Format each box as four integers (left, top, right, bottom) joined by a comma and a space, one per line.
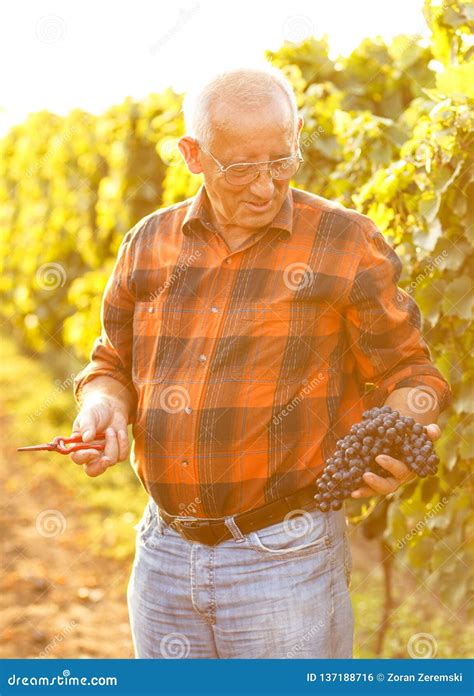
345, 220, 452, 412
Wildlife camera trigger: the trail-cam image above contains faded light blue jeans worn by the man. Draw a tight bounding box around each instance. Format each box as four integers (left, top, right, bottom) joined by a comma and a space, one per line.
127, 499, 354, 659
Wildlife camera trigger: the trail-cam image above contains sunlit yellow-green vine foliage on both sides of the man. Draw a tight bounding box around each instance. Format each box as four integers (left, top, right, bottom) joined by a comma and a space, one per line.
0, 1, 474, 607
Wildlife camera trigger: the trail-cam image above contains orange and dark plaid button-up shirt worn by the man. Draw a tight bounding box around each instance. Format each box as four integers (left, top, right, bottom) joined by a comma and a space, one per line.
74, 187, 451, 517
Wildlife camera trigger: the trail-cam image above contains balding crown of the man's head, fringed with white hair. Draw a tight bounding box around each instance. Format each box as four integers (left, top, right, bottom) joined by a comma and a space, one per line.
183, 67, 298, 147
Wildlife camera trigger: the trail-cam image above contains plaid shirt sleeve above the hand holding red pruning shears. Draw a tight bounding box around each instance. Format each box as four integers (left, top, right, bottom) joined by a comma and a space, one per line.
73, 228, 137, 423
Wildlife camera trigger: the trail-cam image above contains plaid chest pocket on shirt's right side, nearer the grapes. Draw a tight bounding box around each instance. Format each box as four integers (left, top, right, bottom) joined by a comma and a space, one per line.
229, 302, 315, 384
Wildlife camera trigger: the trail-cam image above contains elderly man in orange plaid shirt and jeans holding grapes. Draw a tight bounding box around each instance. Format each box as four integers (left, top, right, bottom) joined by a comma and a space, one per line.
71, 65, 451, 658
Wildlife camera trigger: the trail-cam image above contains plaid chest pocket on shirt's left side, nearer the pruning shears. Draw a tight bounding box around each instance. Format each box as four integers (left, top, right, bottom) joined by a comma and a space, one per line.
132, 299, 180, 385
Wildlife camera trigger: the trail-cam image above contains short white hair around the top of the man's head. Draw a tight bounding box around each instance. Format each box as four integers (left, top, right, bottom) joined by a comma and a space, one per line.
183, 66, 298, 145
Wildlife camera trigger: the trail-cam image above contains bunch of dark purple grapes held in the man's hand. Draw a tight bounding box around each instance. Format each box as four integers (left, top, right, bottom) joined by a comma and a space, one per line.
314, 406, 439, 512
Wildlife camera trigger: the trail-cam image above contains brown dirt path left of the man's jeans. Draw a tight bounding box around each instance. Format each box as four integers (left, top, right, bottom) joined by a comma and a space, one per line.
0, 429, 133, 658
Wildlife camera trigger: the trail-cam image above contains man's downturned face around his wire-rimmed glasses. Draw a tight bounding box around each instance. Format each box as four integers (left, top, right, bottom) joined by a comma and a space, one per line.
181, 96, 299, 229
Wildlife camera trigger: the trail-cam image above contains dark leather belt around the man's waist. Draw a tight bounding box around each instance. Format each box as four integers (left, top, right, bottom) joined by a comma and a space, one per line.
159, 484, 316, 546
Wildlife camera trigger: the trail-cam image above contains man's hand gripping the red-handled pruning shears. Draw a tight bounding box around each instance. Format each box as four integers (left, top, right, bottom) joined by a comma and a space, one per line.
69, 396, 130, 476
